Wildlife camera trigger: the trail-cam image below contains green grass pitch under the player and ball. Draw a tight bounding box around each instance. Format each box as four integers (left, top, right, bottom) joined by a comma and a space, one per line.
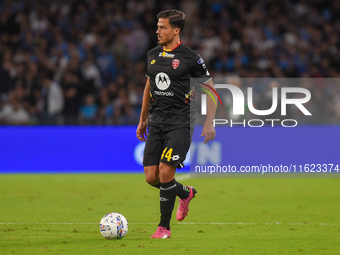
0, 174, 340, 255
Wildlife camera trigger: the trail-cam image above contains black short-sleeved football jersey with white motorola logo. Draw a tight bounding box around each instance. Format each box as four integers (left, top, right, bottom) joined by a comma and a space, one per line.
146, 42, 211, 128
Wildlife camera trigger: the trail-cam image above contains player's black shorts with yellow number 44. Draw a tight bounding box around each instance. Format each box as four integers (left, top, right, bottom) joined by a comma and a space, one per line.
143, 126, 193, 169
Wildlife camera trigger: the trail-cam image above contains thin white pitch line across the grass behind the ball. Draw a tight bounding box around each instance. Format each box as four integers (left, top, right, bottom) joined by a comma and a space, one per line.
0, 222, 340, 226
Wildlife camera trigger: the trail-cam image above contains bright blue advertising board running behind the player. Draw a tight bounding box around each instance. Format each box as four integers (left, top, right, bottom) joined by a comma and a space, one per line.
0, 126, 340, 173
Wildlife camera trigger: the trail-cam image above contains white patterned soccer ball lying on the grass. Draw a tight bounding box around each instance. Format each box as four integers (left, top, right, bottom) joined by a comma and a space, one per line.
99, 212, 128, 240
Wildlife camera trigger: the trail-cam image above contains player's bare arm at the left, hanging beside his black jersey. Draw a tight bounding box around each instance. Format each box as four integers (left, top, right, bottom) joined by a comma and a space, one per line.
136, 78, 150, 142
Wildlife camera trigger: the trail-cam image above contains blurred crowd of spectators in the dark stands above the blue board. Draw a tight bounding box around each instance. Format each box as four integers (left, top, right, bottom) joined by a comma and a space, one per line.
0, 0, 340, 125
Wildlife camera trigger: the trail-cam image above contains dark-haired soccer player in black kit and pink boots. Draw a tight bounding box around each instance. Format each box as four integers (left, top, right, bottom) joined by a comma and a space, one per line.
136, 10, 216, 238
